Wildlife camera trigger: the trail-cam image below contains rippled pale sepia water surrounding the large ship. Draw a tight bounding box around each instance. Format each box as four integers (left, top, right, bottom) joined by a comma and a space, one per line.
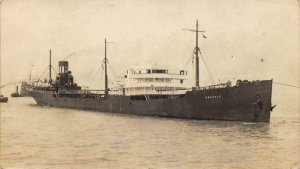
0, 98, 300, 169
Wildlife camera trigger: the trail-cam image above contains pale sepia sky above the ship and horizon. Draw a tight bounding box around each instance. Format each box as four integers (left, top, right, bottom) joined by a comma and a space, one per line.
0, 0, 300, 92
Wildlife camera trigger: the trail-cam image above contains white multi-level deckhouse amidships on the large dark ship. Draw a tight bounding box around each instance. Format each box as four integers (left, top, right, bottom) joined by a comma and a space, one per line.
116, 65, 187, 96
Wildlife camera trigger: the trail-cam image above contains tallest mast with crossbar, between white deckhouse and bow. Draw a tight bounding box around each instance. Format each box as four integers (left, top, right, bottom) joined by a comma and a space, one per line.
185, 19, 206, 87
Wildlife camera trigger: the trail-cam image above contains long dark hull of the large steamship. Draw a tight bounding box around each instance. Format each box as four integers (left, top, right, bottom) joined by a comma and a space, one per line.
30, 80, 272, 122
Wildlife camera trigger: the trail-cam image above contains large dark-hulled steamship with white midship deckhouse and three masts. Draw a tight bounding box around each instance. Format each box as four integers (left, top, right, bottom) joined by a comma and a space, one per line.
30, 22, 272, 122
